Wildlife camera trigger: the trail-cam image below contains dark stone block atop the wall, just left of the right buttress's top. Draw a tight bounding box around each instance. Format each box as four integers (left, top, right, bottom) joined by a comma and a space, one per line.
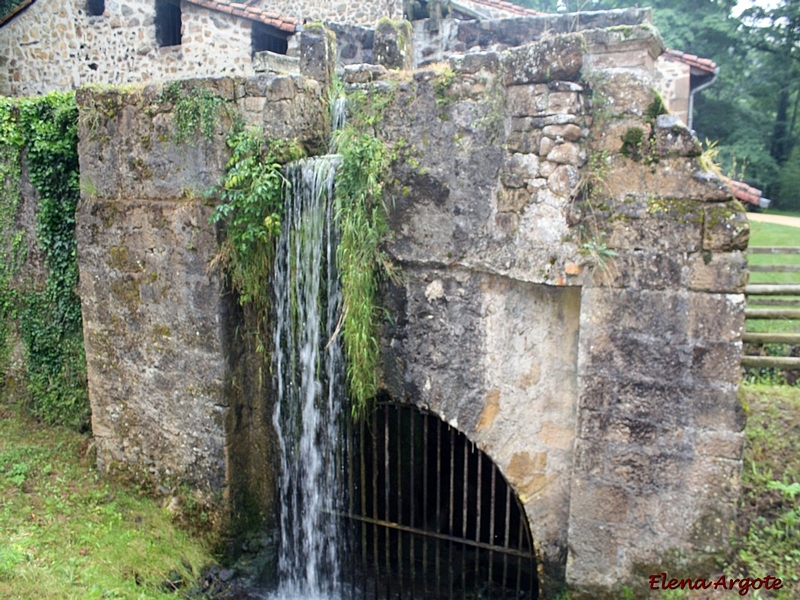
500, 33, 583, 85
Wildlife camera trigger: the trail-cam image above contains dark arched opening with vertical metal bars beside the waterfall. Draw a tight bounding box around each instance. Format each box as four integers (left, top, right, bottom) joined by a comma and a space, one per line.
342, 403, 538, 600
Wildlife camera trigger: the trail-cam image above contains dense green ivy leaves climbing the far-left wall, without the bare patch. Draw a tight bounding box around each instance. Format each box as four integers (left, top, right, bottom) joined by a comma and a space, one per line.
0, 93, 89, 428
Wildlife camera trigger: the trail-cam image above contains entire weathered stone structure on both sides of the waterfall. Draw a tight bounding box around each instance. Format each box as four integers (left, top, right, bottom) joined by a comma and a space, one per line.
64, 17, 748, 598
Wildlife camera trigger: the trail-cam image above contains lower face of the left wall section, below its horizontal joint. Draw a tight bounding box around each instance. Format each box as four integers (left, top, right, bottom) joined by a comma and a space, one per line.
77, 200, 226, 501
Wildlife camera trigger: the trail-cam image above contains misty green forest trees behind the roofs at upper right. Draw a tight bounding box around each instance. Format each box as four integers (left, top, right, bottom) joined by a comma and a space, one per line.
513, 0, 800, 211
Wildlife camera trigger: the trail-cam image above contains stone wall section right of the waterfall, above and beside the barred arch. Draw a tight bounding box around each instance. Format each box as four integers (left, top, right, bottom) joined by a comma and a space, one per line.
345, 25, 747, 598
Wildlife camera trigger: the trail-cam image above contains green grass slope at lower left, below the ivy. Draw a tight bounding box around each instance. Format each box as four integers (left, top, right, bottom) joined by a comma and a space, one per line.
0, 404, 213, 600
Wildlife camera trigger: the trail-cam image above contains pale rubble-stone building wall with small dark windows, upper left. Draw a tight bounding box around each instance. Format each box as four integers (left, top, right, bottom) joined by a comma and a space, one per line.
0, 0, 268, 96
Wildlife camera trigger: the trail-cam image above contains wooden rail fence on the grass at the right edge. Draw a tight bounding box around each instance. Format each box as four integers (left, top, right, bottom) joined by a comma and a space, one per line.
742, 246, 800, 370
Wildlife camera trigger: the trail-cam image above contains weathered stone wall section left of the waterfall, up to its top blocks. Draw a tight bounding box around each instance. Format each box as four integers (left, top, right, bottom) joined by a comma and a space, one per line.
76, 75, 327, 526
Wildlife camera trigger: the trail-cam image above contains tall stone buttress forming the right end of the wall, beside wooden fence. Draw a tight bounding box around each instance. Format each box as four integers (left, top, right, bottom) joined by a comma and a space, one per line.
567, 27, 748, 598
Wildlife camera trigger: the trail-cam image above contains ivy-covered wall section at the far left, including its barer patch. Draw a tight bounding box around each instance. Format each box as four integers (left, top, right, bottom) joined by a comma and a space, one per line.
0, 93, 89, 429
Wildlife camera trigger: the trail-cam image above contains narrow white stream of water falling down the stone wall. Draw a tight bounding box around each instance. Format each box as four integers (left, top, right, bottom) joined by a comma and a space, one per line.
273, 156, 344, 600
